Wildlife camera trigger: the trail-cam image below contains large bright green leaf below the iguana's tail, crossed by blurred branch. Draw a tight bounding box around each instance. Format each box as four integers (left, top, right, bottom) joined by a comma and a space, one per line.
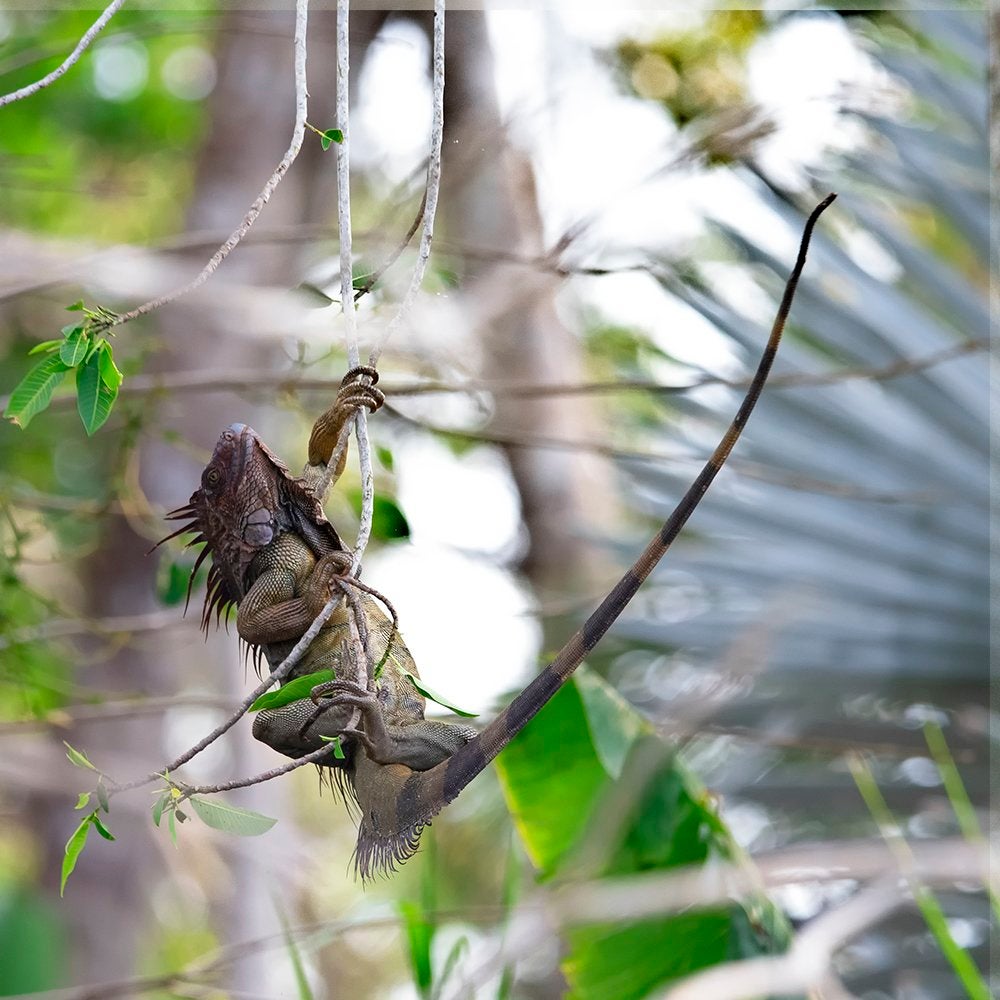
497, 668, 788, 1000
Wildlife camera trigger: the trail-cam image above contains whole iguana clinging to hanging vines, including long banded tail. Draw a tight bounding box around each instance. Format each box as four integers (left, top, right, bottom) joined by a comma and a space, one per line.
160, 195, 835, 880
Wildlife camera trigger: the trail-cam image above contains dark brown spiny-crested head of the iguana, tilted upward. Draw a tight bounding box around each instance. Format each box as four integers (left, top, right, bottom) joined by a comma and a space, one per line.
157, 424, 343, 629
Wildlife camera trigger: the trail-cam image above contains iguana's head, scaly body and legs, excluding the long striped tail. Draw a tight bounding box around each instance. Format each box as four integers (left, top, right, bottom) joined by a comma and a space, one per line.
164, 370, 476, 878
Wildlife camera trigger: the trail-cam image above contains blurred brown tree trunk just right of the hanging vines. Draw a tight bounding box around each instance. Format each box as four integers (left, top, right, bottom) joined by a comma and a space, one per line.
440, 11, 613, 620
